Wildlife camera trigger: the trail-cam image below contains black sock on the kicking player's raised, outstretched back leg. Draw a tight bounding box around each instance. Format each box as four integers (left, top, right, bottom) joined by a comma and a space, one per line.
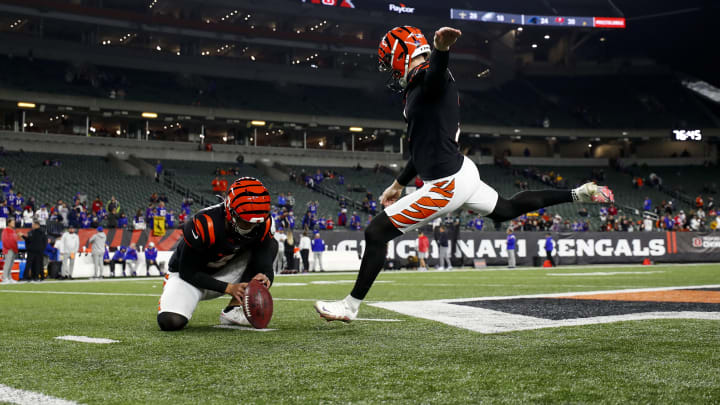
488, 190, 573, 222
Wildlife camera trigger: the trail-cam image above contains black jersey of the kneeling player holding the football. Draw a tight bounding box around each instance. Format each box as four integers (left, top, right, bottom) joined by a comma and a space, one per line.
168, 204, 278, 292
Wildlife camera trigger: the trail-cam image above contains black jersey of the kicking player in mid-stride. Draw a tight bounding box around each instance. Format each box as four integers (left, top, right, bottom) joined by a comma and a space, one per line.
397, 50, 463, 185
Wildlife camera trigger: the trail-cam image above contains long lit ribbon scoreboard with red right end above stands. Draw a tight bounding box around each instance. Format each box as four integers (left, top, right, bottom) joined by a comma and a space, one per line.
450, 8, 625, 28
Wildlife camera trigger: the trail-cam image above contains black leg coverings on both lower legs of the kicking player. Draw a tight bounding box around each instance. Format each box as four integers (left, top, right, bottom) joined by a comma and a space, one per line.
350, 190, 573, 299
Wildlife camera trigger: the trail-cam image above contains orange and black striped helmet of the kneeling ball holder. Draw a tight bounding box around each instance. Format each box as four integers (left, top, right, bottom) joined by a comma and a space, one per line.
225, 177, 271, 226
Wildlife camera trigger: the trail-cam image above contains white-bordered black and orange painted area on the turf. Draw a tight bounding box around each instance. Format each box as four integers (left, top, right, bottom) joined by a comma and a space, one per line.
370, 285, 720, 333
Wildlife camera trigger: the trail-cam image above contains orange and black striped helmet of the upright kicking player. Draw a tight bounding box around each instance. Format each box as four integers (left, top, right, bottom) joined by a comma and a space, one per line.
378, 25, 430, 91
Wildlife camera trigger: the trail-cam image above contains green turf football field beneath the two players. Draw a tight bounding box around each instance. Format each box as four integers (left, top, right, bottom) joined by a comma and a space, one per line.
0, 265, 720, 404
